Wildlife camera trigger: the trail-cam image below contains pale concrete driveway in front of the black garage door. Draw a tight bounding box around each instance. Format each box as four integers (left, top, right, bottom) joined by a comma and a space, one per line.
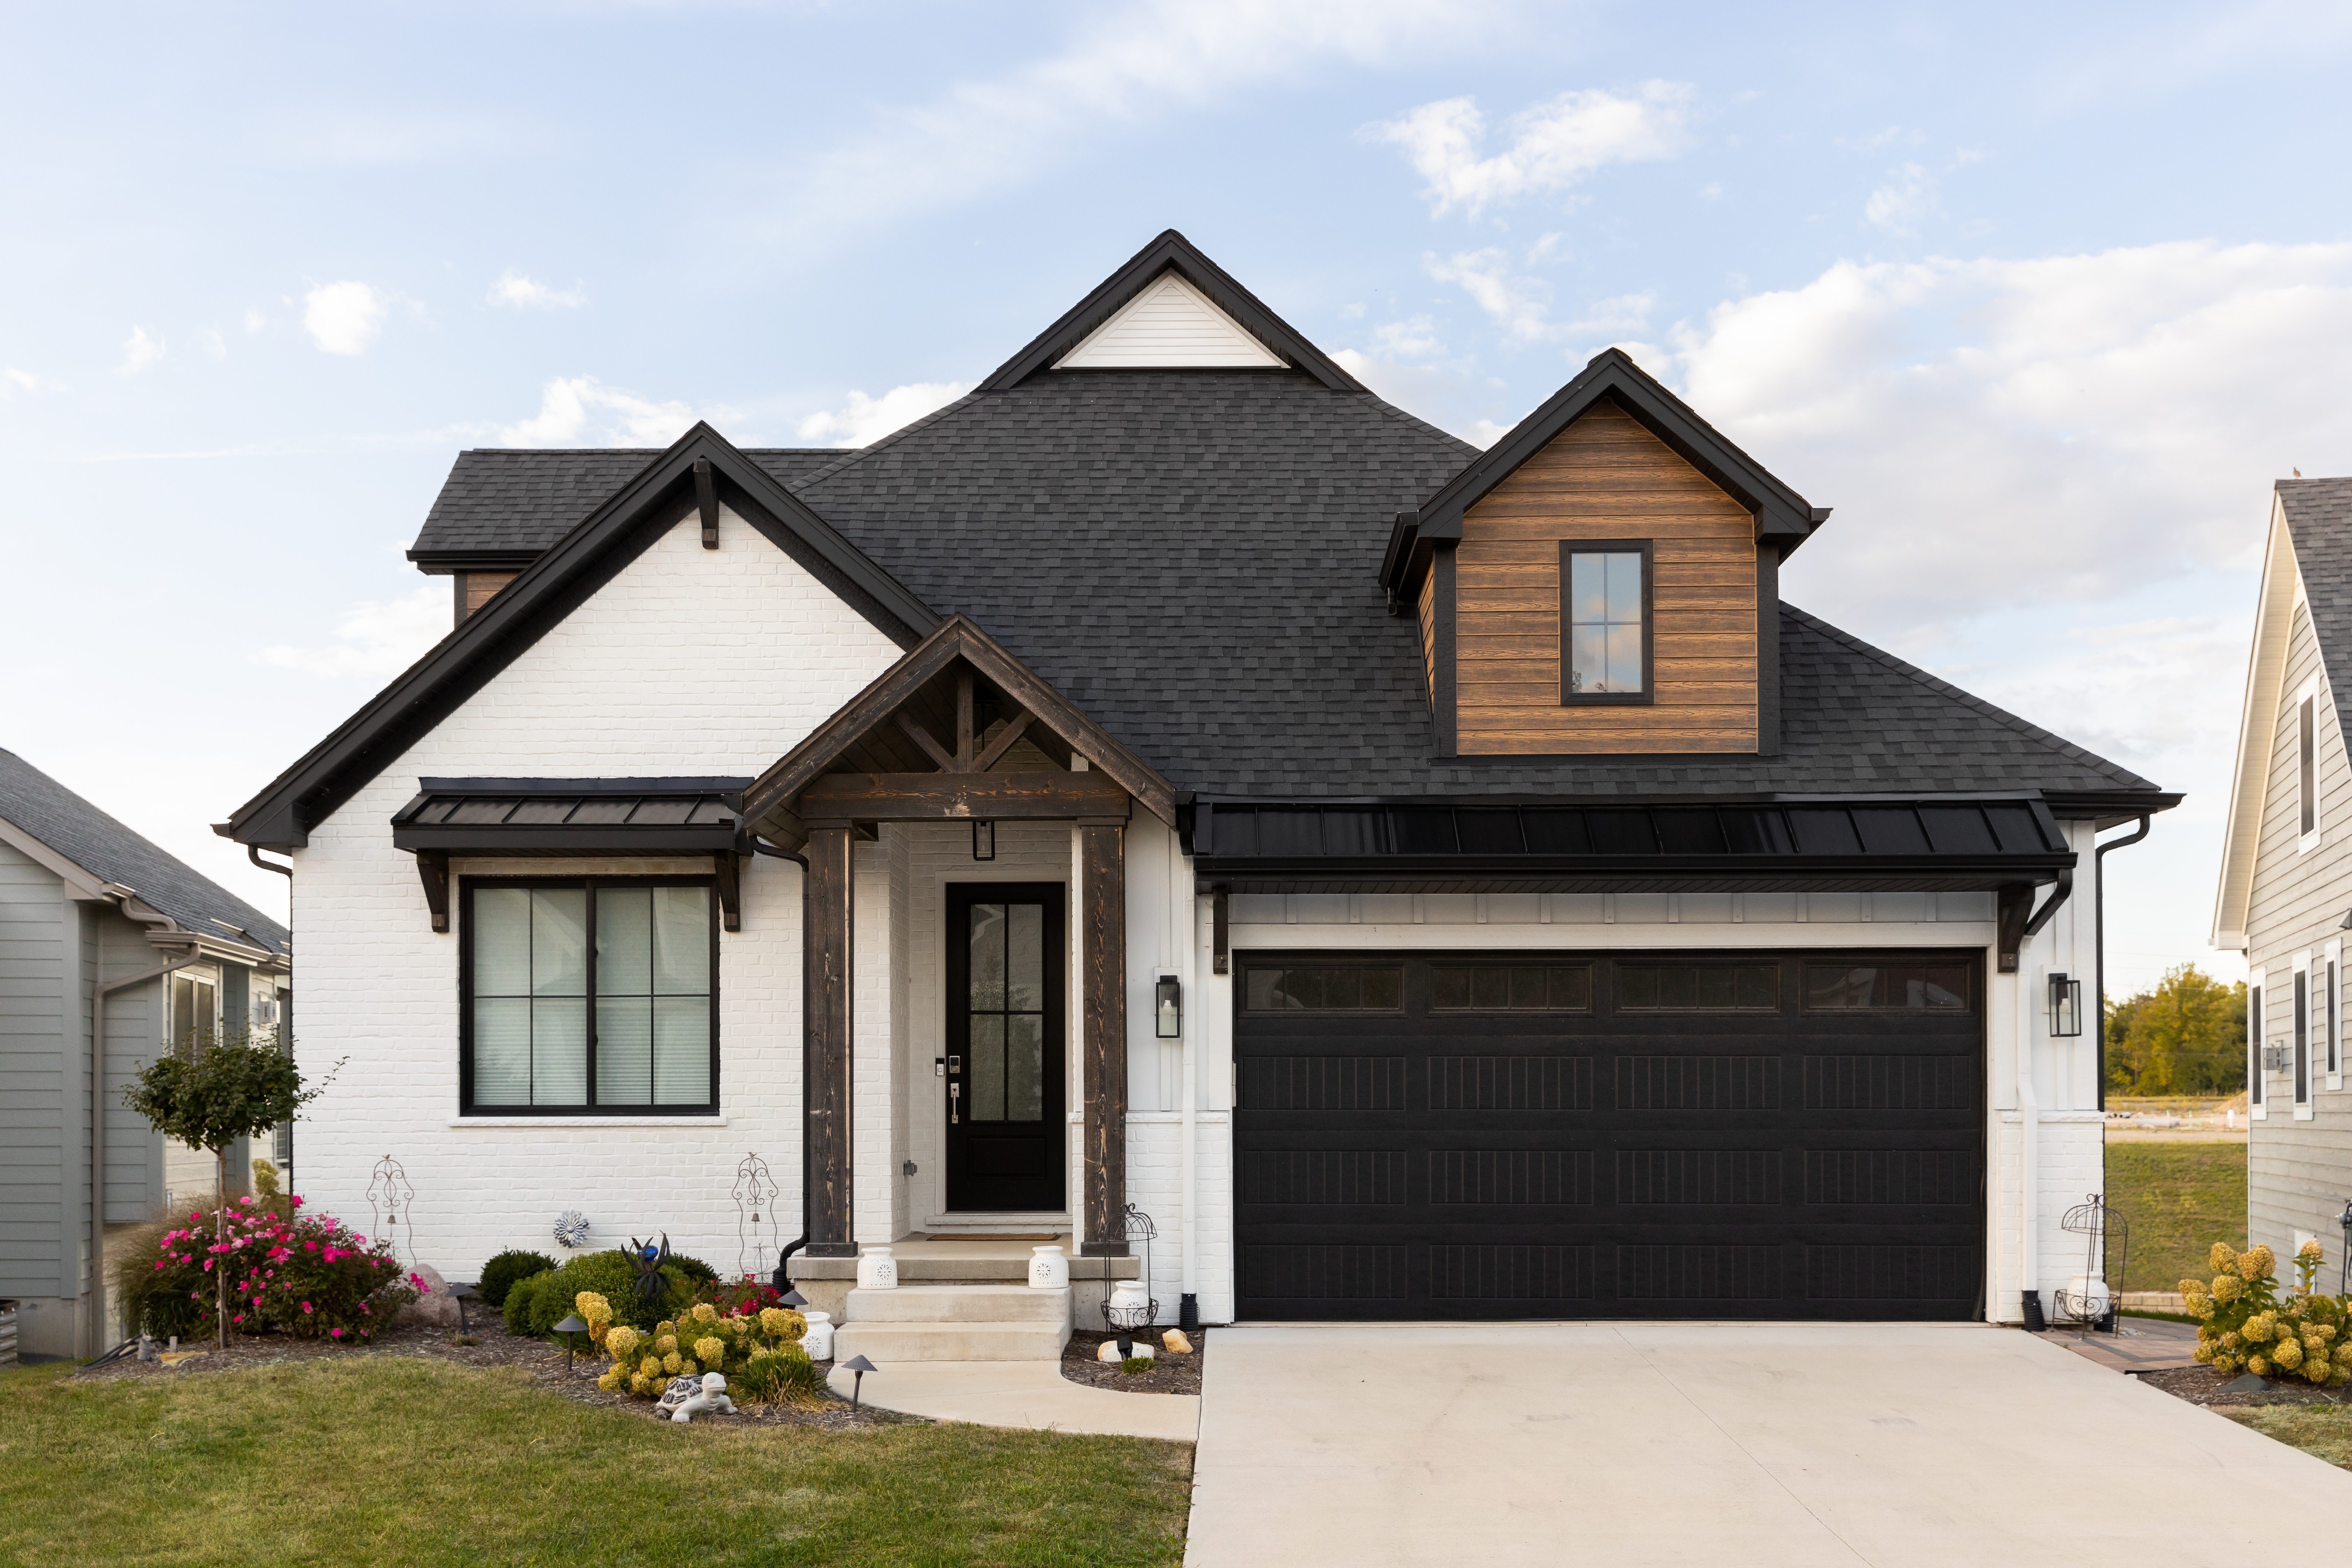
1185, 1323, 2352, 1568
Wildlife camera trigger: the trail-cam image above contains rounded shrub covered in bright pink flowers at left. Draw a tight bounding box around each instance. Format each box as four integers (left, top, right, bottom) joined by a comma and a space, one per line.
125, 1196, 421, 1345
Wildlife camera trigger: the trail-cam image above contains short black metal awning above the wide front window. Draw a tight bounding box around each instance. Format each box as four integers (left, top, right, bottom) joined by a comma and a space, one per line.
393, 778, 750, 856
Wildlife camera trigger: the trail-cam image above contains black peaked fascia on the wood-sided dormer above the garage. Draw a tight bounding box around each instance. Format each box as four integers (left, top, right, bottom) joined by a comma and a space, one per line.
1383, 348, 1828, 592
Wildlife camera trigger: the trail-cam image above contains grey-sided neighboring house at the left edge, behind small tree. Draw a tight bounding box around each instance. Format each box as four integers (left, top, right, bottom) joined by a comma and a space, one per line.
0, 752, 292, 1356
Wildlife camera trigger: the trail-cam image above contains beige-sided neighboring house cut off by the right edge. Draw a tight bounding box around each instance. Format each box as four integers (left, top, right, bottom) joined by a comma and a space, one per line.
2213, 480, 2352, 1258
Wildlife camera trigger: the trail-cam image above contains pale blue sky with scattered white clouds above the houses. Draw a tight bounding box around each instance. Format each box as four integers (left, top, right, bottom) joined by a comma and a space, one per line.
0, 0, 2352, 985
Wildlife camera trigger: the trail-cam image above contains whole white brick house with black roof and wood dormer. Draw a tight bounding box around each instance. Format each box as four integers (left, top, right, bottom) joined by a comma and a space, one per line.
224, 233, 2178, 1354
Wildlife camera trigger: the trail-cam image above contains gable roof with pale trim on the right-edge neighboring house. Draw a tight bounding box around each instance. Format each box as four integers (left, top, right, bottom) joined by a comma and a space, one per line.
2213, 480, 2352, 952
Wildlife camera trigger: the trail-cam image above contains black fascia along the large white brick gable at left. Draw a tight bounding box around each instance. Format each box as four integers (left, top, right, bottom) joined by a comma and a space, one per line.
214, 423, 941, 849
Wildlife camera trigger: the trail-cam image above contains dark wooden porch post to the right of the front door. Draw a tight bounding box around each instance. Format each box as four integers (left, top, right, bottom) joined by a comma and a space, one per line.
1077, 823, 1127, 1258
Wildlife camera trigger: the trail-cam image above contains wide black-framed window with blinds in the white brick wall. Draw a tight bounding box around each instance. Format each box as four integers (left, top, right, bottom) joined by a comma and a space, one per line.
463, 877, 718, 1112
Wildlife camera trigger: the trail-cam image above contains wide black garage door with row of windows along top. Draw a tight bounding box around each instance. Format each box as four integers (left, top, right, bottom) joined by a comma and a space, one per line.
1233, 952, 1985, 1321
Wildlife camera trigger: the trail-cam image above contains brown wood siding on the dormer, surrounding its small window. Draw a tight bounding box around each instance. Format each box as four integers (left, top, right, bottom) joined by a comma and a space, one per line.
1423, 400, 1778, 757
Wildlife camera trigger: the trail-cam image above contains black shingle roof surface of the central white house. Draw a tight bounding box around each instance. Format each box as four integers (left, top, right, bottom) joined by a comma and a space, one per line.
395, 372, 2154, 797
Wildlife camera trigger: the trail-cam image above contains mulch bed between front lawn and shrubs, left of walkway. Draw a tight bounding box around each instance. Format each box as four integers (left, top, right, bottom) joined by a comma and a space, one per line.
75, 1316, 908, 1432
